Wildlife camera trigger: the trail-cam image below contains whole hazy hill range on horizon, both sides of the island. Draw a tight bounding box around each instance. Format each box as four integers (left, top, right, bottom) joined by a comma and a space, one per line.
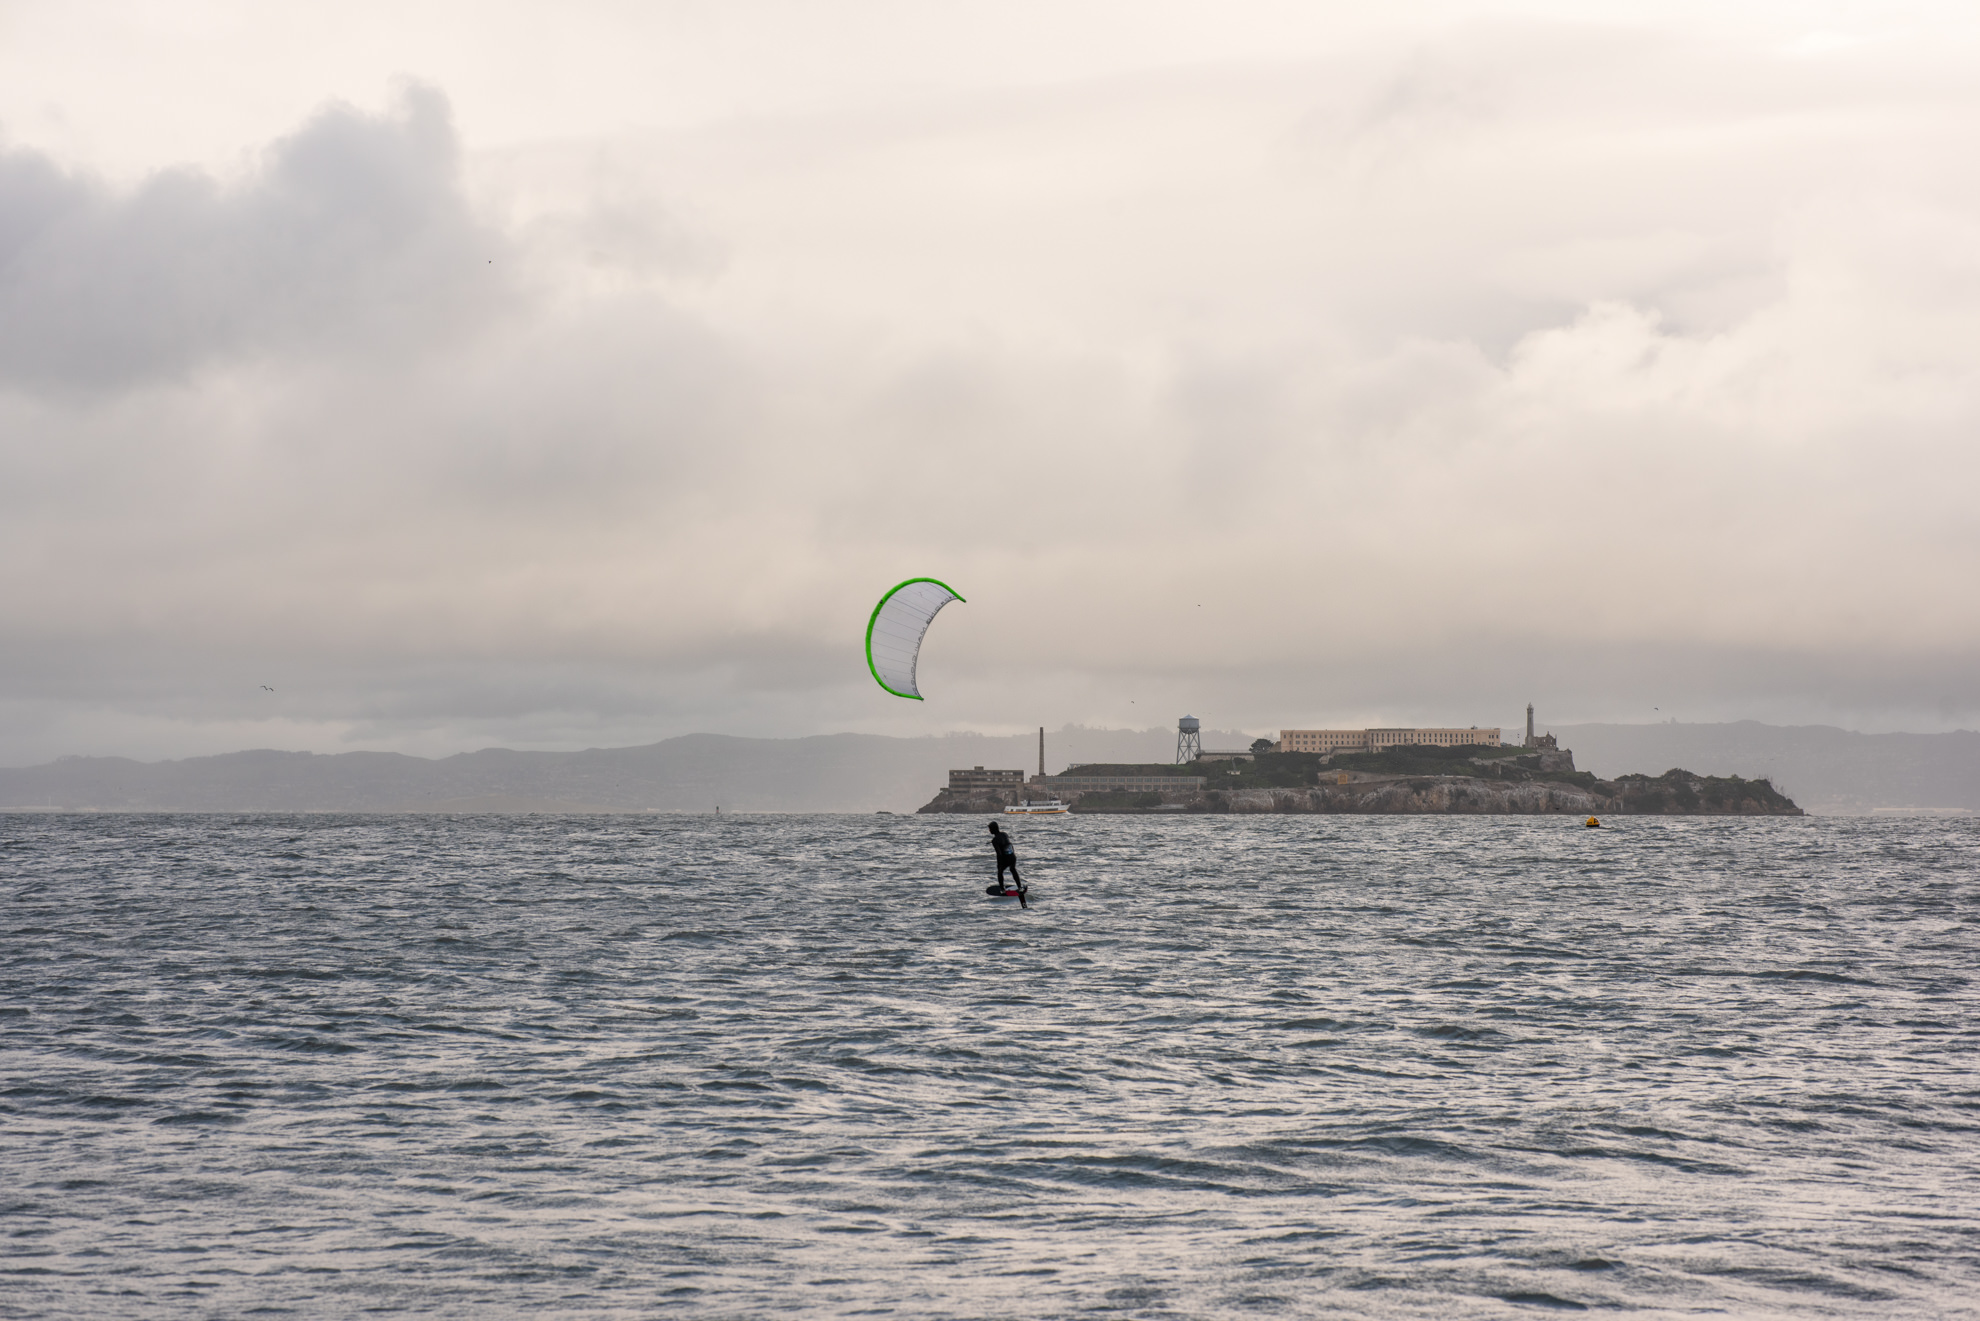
0, 721, 1980, 814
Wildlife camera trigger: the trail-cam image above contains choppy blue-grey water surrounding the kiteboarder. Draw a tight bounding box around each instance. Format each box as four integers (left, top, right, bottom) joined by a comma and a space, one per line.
0, 816, 1980, 1317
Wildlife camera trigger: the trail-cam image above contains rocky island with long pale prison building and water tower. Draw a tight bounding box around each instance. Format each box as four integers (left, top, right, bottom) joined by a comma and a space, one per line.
921, 745, 1802, 816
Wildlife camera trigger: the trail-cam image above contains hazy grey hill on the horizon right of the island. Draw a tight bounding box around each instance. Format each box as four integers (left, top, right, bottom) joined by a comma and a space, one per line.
1554, 721, 1980, 816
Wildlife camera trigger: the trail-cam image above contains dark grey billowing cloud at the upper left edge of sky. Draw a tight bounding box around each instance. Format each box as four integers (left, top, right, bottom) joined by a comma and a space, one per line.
0, 87, 509, 390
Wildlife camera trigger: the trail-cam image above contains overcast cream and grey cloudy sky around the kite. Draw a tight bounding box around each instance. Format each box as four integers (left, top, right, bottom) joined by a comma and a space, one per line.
0, 0, 1980, 764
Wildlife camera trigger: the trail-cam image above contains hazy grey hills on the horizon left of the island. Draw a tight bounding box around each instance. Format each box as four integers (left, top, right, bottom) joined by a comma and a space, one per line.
0, 729, 1239, 812
